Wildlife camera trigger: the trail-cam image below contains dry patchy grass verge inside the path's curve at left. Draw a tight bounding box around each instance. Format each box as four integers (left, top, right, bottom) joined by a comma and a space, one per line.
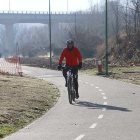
0, 75, 59, 139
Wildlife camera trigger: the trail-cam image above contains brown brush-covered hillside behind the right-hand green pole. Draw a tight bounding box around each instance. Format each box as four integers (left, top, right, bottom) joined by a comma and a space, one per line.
97, 35, 140, 66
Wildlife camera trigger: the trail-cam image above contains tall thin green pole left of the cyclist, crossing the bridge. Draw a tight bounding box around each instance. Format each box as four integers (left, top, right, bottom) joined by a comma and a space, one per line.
49, 0, 52, 68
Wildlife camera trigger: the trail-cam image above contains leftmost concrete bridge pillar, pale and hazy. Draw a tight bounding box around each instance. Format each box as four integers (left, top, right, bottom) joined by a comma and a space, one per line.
5, 24, 14, 54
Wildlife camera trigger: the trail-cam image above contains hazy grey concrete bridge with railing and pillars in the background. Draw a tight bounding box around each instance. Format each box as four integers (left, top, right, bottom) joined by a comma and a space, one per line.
0, 11, 90, 52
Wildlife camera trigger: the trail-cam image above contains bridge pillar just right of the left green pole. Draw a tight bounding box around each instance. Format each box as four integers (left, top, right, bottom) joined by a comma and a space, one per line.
52, 22, 60, 47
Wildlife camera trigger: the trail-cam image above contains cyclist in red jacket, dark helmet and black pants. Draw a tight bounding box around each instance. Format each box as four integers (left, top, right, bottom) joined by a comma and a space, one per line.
58, 40, 82, 99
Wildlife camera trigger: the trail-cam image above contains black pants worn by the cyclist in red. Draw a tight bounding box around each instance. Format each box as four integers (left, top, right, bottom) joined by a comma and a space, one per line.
63, 68, 78, 94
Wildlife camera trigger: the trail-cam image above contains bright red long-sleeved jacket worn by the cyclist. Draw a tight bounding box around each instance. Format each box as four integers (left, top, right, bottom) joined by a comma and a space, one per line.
59, 47, 82, 66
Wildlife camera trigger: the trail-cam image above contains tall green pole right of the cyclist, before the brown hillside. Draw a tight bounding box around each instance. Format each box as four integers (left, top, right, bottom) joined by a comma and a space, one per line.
105, 0, 108, 75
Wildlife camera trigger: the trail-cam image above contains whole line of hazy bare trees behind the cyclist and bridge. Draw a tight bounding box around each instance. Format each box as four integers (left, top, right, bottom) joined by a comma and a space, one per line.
0, 0, 140, 58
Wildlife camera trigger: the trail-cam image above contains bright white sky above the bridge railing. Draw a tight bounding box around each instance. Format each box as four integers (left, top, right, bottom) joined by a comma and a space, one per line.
0, 0, 101, 11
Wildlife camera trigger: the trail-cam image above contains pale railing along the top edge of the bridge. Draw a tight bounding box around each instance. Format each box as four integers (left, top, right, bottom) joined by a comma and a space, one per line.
0, 11, 91, 14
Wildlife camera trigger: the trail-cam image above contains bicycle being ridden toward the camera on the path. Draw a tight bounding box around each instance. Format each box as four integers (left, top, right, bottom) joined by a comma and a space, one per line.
62, 66, 78, 104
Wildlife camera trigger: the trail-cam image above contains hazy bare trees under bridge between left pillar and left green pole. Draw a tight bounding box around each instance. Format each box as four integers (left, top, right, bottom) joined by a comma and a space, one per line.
16, 26, 49, 56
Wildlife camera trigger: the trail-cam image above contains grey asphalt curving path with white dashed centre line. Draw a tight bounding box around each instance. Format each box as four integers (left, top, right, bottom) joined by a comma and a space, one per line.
3, 67, 140, 140
